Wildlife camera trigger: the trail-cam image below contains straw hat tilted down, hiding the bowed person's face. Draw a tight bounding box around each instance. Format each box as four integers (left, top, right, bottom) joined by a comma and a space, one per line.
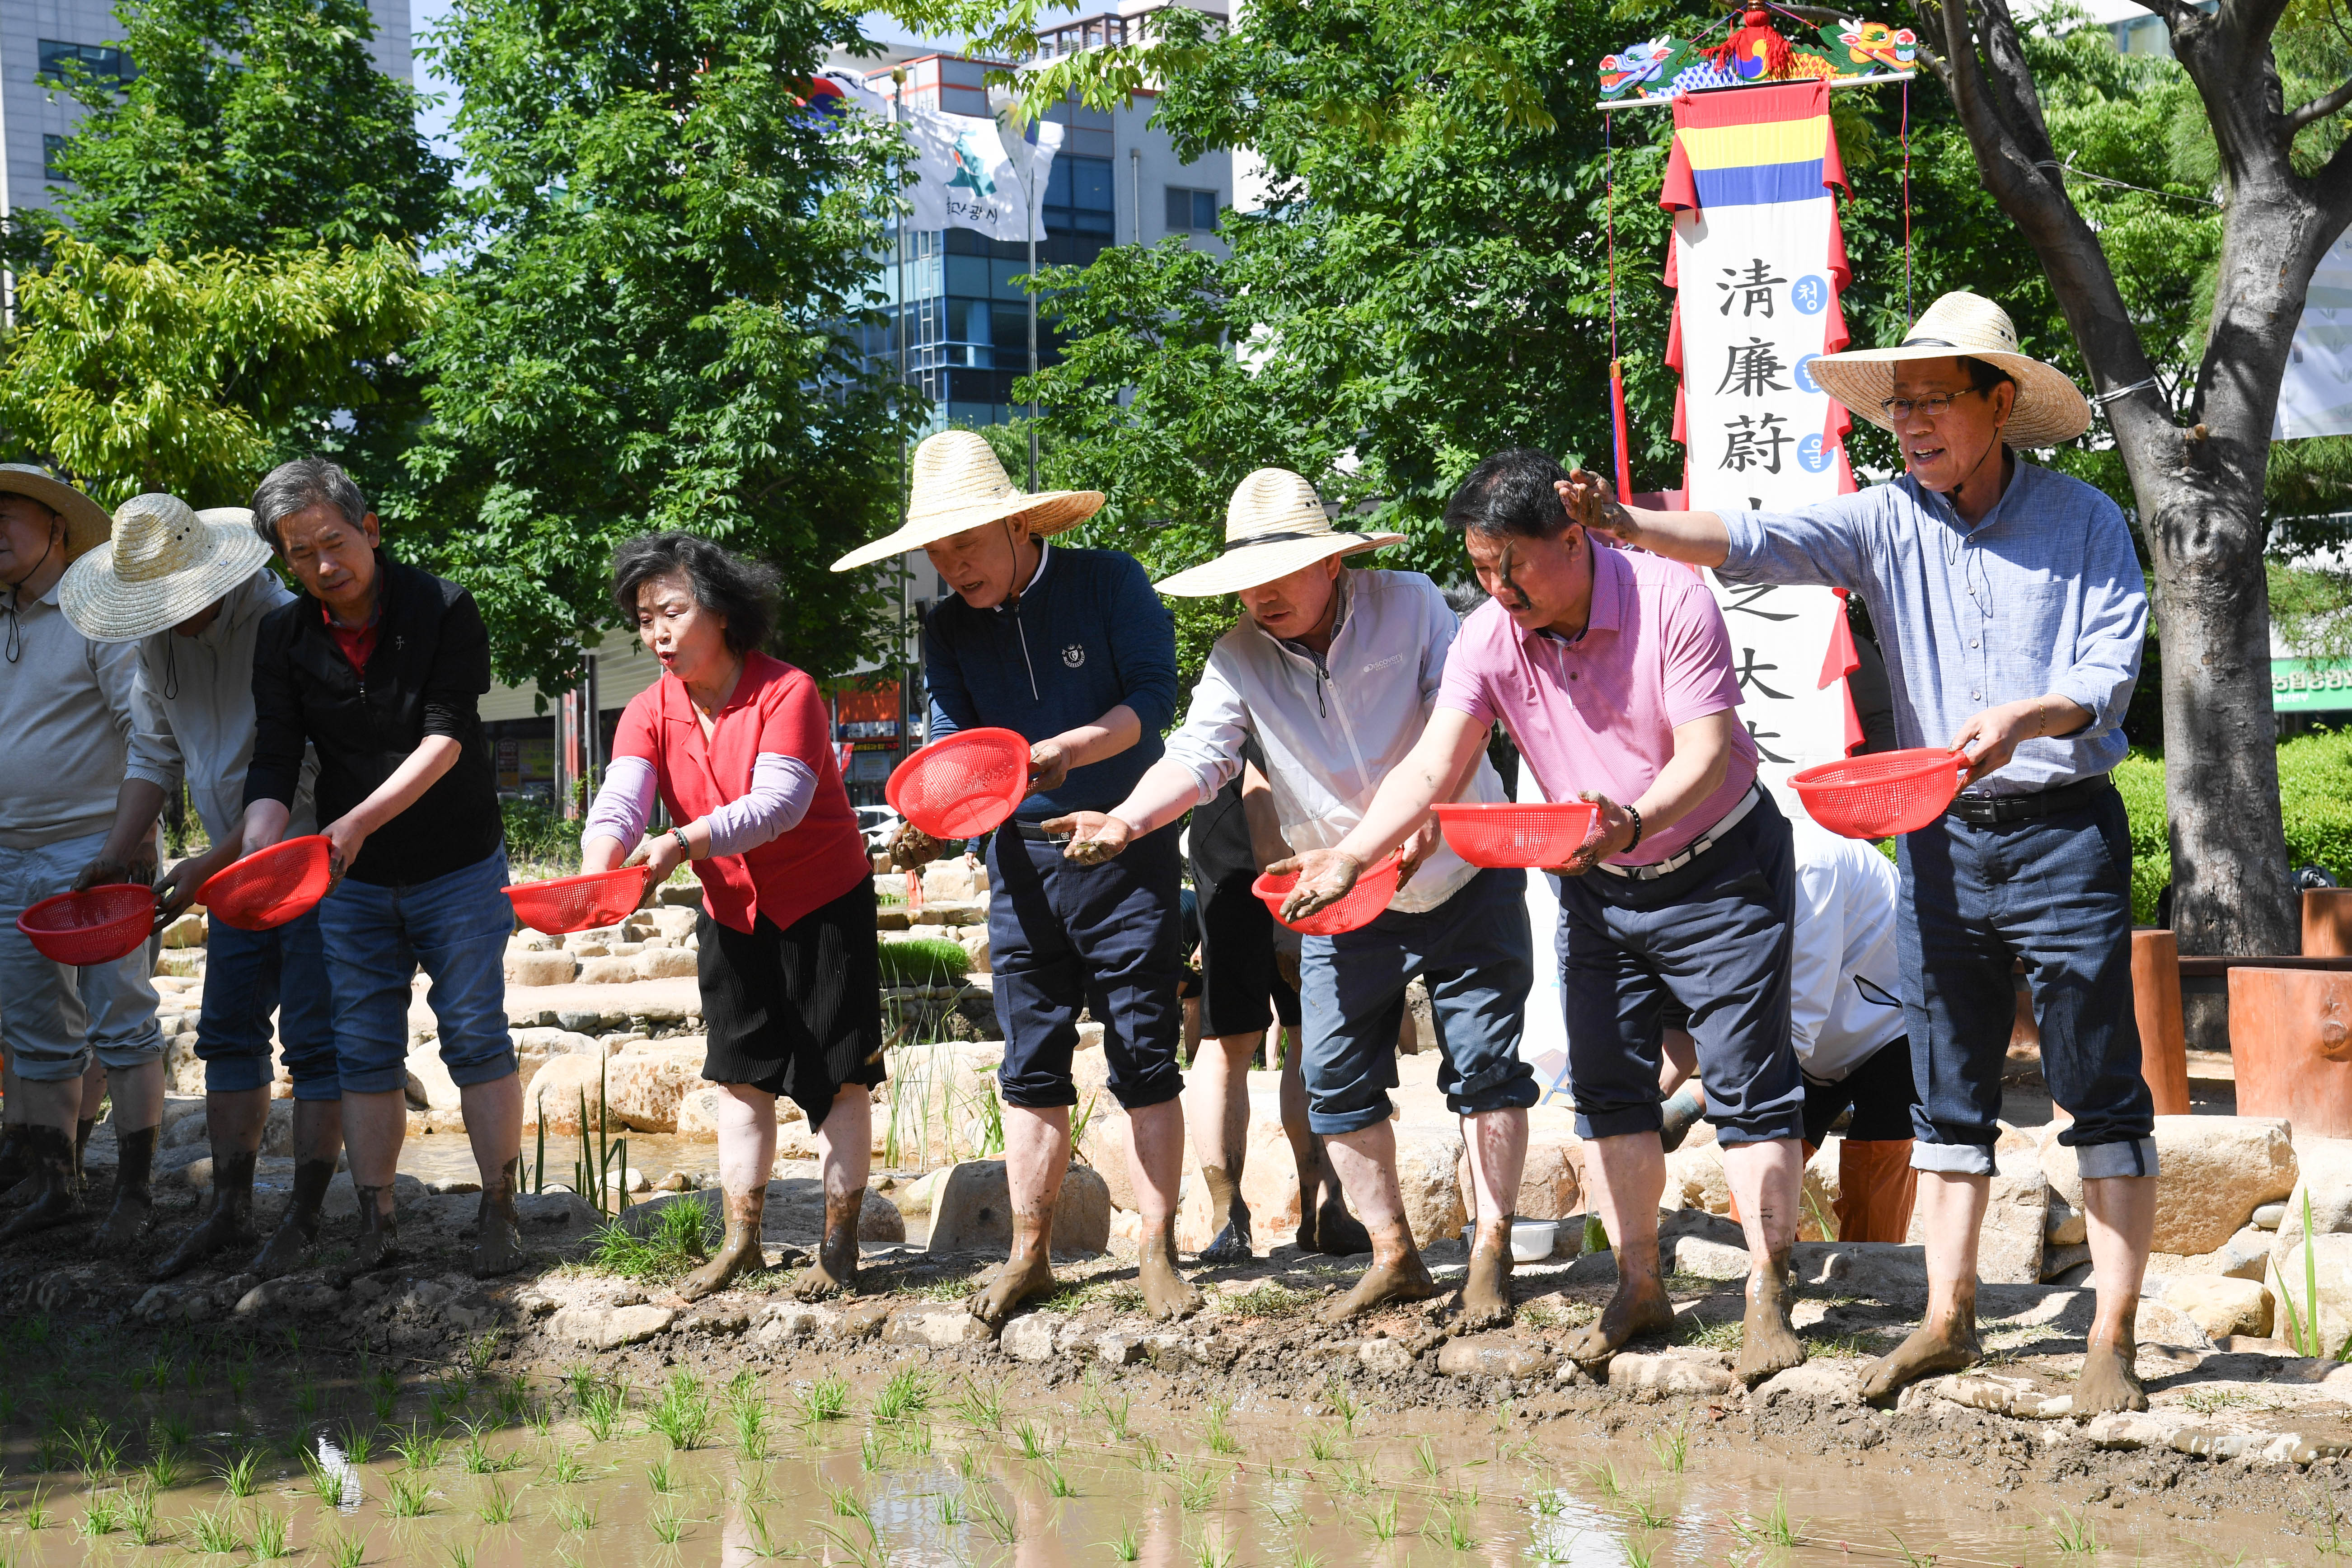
56, 494, 271, 642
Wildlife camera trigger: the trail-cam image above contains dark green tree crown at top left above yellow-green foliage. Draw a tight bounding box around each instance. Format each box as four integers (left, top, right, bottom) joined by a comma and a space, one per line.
37, 0, 452, 261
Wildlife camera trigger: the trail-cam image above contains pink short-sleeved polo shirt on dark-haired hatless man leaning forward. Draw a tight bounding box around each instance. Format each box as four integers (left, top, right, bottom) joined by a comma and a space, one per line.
1437, 545, 1757, 865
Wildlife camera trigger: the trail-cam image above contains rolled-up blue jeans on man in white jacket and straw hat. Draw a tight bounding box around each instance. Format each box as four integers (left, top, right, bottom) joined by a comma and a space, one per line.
1298, 870, 1543, 1138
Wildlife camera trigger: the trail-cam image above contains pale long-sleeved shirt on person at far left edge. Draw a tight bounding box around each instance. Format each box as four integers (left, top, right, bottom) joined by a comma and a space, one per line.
0, 583, 176, 846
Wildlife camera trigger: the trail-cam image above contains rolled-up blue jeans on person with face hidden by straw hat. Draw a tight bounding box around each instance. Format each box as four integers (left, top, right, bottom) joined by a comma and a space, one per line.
195, 910, 343, 1100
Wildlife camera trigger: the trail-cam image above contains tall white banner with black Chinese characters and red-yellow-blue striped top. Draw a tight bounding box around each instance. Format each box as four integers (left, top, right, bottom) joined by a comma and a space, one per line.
1658, 80, 1860, 787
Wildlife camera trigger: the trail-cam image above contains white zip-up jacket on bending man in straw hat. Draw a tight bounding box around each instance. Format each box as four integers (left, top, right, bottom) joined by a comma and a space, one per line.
1167, 571, 1508, 914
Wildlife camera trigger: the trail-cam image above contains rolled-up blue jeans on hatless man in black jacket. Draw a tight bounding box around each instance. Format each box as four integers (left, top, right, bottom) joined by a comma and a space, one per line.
318, 849, 515, 1095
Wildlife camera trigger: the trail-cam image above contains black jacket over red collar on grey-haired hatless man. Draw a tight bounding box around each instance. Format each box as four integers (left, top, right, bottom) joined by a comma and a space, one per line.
244, 550, 506, 886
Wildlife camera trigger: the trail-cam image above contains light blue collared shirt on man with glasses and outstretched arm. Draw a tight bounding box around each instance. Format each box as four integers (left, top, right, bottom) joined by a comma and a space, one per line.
1715, 459, 2147, 795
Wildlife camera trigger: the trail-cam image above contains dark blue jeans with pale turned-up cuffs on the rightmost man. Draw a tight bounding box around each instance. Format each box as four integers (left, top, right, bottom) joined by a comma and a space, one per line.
1900, 790, 2157, 1178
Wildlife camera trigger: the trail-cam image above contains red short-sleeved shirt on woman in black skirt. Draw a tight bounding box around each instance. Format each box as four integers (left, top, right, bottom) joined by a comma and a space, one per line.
612, 654, 872, 931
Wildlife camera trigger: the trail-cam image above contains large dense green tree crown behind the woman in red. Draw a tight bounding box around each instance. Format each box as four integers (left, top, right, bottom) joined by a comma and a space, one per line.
393, 0, 908, 691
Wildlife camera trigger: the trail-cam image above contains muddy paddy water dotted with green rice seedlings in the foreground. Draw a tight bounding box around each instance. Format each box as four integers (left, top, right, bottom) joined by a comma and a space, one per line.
0, 1330, 2310, 1568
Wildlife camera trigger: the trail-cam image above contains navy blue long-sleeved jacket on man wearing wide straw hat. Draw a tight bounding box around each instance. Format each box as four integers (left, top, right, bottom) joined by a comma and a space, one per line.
922, 545, 1176, 823
